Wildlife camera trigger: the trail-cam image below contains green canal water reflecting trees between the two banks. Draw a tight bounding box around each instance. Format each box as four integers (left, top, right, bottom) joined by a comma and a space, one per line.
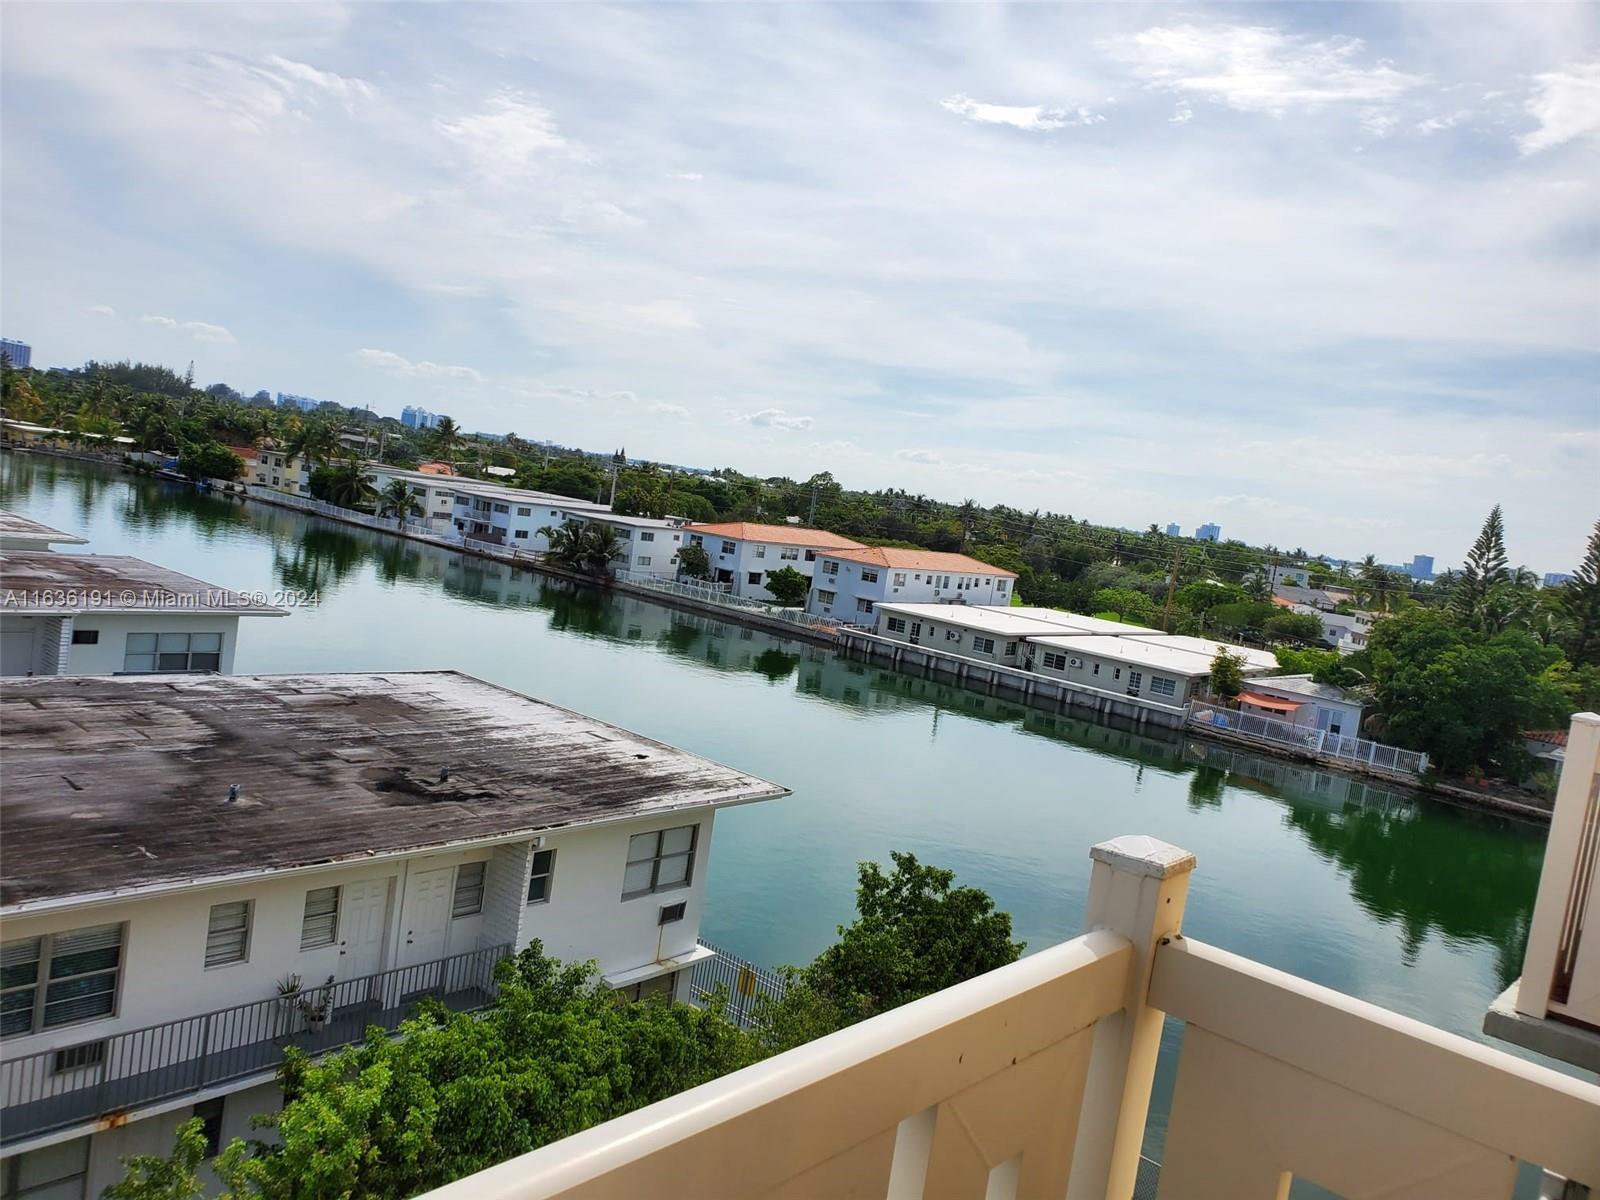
0, 453, 1544, 1177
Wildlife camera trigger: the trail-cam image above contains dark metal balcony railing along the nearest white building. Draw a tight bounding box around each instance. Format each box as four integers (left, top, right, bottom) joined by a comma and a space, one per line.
0, 946, 510, 1146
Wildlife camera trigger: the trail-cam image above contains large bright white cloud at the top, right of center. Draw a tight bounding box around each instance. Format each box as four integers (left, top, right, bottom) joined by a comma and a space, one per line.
1099, 26, 1421, 115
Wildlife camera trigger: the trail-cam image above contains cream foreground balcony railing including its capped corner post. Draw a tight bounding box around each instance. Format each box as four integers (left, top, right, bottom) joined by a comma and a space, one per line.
416, 837, 1600, 1200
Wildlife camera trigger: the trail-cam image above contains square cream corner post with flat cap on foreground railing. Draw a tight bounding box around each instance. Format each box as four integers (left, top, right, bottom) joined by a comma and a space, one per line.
1067, 835, 1195, 1200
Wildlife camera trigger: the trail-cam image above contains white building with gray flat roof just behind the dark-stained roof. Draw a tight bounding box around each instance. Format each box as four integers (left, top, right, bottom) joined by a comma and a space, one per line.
0, 550, 285, 686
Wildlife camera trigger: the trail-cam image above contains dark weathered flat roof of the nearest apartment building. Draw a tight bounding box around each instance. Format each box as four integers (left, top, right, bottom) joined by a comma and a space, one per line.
0, 670, 787, 912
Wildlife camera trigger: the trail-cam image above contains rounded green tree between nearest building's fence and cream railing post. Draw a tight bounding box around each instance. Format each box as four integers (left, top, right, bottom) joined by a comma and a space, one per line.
758, 851, 1022, 1051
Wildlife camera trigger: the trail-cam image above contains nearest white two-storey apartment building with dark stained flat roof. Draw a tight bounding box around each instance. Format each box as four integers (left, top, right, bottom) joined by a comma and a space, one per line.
0, 672, 784, 1200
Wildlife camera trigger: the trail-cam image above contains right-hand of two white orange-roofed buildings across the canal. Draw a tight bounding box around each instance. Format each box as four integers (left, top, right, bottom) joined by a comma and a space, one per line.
806, 546, 1016, 626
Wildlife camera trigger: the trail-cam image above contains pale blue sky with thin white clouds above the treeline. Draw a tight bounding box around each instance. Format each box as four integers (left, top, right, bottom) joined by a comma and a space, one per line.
0, 3, 1600, 571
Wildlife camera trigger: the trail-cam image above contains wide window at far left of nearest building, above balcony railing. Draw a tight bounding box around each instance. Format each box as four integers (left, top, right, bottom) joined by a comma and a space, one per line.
0, 925, 123, 1035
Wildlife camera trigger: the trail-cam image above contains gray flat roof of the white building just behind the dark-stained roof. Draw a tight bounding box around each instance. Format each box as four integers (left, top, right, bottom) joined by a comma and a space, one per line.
0, 550, 286, 616
